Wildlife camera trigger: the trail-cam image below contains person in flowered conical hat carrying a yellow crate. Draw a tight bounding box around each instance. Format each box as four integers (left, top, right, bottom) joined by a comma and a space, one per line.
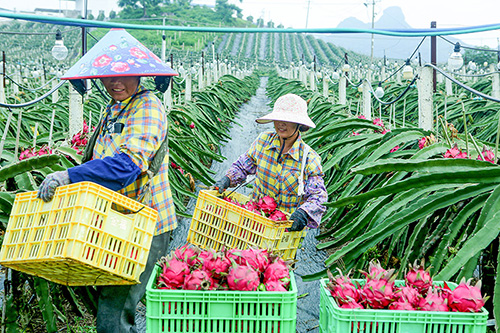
38, 29, 177, 332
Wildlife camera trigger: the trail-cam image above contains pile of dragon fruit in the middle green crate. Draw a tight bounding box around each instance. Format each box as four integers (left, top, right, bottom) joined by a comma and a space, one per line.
156, 244, 290, 292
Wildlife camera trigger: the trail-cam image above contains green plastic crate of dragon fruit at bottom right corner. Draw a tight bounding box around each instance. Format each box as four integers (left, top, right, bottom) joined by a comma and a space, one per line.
319, 279, 488, 333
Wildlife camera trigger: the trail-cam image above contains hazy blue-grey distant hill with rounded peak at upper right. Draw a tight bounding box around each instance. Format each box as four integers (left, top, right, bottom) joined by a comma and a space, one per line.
315, 6, 463, 62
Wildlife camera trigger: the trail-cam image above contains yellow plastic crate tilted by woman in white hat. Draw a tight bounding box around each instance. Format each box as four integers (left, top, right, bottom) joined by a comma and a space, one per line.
187, 190, 305, 260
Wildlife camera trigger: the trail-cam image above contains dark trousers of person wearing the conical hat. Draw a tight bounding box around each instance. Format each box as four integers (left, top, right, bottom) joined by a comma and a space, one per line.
97, 232, 170, 333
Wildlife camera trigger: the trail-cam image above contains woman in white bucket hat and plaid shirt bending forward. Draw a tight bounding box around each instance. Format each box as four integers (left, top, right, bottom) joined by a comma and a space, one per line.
215, 94, 327, 231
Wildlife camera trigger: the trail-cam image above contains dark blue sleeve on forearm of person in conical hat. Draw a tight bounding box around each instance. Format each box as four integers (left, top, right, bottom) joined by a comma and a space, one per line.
68, 153, 141, 191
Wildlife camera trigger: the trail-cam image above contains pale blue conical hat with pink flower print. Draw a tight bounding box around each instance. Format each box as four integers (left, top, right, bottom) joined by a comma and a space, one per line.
61, 29, 178, 80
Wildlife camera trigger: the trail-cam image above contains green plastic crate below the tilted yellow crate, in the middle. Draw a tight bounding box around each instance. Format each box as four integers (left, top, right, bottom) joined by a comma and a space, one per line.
146, 268, 297, 333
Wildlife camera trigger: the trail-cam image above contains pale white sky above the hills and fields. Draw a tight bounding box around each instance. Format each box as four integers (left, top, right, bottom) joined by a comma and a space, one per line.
0, 0, 500, 48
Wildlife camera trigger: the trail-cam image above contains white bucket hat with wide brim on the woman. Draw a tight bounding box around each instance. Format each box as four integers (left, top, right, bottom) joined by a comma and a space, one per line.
255, 94, 316, 128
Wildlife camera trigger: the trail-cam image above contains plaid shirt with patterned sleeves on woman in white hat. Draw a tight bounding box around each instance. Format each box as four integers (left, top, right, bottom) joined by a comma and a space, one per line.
226, 131, 328, 228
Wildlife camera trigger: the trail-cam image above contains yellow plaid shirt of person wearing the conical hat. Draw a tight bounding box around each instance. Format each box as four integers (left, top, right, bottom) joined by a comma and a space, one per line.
93, 85, 177, 235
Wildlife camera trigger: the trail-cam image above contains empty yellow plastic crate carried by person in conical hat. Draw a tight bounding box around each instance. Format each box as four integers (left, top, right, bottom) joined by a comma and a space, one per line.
0, 182, 158, 286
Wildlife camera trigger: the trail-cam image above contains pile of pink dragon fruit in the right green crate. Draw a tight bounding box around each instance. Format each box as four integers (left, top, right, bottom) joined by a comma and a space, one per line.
326, 260, 488, 312
